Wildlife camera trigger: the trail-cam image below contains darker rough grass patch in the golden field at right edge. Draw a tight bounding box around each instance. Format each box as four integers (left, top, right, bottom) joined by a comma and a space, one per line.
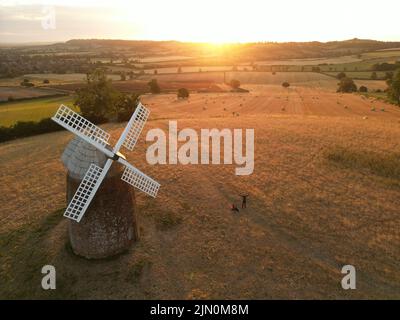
324, 146, 400, 186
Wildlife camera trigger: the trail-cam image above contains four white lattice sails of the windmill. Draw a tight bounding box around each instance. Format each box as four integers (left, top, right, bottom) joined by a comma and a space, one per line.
51, 103, 160, 222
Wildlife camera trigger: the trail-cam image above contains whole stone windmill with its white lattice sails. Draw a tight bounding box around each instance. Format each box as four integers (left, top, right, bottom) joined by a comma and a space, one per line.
52, 104, 160, 258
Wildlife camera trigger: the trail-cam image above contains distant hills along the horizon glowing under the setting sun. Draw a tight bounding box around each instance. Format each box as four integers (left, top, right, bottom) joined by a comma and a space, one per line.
3, 39, 400, 62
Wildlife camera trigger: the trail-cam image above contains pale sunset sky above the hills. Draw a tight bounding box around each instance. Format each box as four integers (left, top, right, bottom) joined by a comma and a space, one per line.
0, 0, 400, 43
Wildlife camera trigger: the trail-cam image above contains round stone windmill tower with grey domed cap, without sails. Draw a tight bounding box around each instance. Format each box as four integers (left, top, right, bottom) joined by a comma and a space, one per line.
62, 137, 139, 259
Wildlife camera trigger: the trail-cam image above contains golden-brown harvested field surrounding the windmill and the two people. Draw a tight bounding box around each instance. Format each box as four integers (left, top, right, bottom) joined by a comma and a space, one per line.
0, 84, 400, 299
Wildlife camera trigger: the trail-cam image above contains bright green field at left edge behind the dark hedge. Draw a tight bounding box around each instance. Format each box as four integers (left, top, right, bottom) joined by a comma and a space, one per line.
0, 96, 73, 127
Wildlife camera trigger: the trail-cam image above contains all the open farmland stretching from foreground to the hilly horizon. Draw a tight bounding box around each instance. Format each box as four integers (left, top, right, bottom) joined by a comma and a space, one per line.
0, 40, 400, 299
